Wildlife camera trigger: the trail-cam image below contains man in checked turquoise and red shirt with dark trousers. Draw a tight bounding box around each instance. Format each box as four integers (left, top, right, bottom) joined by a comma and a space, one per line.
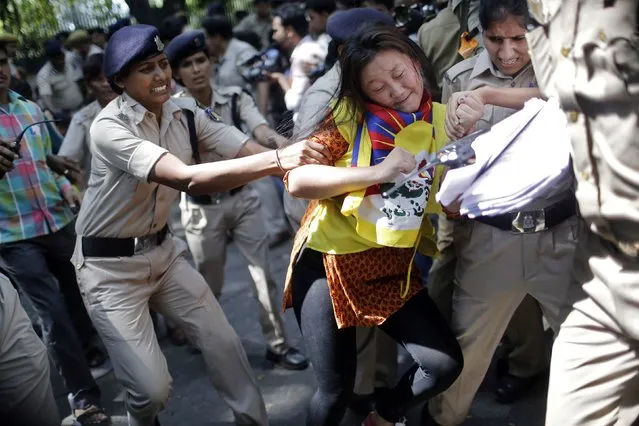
0, 45, 109, 425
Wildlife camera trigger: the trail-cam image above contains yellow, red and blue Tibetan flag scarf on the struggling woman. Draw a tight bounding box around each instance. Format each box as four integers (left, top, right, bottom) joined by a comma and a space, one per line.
333, 93, 445, 248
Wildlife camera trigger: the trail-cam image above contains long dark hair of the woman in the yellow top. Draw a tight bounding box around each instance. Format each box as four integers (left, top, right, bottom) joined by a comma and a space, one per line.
337, 23, 441, 120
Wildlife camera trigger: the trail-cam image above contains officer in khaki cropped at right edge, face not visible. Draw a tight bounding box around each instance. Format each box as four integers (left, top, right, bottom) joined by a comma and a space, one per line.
528, 0, 639, 426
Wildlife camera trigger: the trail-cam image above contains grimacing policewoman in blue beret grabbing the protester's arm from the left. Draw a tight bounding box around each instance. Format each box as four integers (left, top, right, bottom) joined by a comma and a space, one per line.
72, 25, 322, 426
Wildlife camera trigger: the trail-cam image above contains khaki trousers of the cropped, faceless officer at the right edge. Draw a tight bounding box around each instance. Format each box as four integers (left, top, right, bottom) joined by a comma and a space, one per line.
546, 226, 639, 426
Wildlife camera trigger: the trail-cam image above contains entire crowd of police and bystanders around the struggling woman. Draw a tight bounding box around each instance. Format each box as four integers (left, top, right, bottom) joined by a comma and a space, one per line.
0, 0, 639, 426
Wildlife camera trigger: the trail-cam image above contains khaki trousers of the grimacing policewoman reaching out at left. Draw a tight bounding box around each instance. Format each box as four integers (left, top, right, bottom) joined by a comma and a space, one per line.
73, 234, 268, 426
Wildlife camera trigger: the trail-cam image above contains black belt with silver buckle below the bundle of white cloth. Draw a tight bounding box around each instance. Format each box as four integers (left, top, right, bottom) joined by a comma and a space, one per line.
475, 194, 577, 234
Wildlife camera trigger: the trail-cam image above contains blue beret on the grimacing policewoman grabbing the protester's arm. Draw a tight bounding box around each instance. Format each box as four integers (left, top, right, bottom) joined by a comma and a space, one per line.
104, 25, 164, 93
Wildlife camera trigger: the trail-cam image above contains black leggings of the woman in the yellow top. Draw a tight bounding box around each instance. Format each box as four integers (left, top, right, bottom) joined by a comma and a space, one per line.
293, 249, 463, 426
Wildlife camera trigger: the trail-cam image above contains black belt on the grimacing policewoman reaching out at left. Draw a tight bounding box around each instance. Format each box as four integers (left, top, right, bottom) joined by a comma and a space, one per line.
82, 225, 169, 257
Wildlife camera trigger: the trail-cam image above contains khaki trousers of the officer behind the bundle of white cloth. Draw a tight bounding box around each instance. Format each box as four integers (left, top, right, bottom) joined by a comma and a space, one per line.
429, 216, 579, 426
